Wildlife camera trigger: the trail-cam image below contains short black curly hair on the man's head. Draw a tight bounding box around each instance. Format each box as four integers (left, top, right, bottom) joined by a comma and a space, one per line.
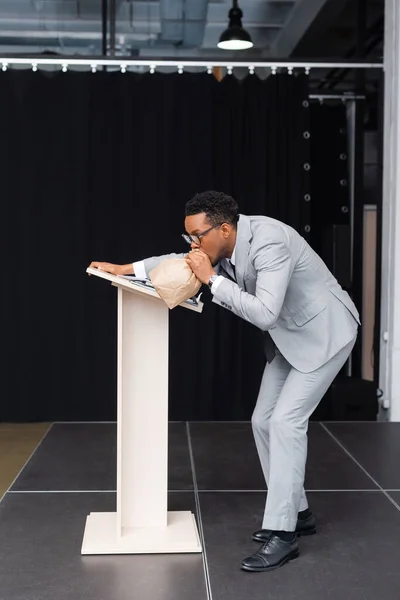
185, 191, 239, 227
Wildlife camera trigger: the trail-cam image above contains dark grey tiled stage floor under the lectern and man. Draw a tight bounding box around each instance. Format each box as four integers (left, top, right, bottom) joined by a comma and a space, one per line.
0, 422, 400, 600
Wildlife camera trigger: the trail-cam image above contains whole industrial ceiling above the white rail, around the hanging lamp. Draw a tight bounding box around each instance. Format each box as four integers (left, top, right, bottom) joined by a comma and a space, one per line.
0, 0, 383, 60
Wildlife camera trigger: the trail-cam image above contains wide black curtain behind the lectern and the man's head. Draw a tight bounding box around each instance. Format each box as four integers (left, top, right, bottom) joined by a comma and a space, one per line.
0, 71, 310, 421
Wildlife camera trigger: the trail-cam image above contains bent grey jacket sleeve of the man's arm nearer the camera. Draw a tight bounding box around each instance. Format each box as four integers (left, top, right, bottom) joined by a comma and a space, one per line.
213, 241, 293, 331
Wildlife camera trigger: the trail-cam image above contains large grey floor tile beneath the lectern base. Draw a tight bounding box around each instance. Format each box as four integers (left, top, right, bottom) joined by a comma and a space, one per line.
0, 492, 207, 600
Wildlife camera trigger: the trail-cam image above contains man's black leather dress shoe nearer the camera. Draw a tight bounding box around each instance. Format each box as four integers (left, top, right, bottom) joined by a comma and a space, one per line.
242, 534, 299, 571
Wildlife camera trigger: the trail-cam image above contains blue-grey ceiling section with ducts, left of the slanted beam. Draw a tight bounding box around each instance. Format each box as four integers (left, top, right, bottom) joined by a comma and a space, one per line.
0, 0, 296, 57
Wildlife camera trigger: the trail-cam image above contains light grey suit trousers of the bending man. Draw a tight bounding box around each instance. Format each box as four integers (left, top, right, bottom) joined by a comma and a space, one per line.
252, 337, 356, 531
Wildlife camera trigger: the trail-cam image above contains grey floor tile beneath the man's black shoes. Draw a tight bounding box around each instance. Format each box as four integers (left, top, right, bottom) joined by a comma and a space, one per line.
200, 492, 400, 600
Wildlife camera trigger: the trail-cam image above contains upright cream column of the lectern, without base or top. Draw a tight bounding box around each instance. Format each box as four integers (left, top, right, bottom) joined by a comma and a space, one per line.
117, 288, 168, 535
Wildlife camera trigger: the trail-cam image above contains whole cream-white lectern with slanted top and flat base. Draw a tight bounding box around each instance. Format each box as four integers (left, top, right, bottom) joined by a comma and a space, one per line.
81, 268, 203, 554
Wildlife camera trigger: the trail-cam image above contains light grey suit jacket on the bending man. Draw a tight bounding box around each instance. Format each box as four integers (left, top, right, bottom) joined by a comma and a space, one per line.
144, 215, 360, 373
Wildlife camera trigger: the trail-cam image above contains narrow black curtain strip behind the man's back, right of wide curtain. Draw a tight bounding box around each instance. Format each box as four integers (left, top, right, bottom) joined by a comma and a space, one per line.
310, 100, 377, 420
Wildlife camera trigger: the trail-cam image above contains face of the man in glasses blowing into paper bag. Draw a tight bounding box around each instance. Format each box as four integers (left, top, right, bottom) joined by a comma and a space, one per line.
185, 213, 231, 266
